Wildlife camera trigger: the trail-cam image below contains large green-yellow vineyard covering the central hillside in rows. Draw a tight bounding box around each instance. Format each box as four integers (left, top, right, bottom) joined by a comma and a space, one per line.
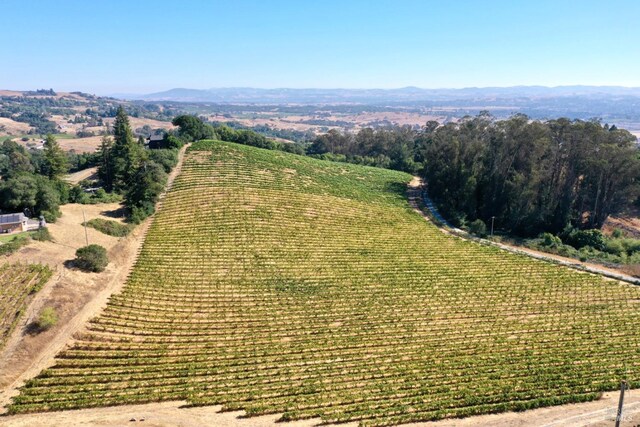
9, 141, 640, 426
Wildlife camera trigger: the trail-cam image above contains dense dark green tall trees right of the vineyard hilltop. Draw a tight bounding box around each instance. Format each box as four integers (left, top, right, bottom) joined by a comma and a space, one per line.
307, 113, 640, 236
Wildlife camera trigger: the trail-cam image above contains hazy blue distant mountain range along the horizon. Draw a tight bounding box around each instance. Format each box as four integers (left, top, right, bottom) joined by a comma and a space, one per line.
112, 86, 640, 105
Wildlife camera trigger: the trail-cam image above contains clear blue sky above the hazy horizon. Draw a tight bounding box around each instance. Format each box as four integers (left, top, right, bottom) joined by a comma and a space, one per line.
0, 0, 640, 94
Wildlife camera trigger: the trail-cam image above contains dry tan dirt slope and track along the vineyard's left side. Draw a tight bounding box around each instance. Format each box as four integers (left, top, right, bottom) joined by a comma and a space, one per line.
0, 147, 186, 412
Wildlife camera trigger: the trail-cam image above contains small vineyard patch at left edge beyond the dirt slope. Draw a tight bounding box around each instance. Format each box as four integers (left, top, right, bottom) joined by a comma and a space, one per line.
0, 263, 51, 347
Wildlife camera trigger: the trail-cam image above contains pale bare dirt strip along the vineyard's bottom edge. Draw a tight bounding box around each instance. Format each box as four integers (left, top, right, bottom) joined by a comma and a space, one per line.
0, 391, 640, 427
